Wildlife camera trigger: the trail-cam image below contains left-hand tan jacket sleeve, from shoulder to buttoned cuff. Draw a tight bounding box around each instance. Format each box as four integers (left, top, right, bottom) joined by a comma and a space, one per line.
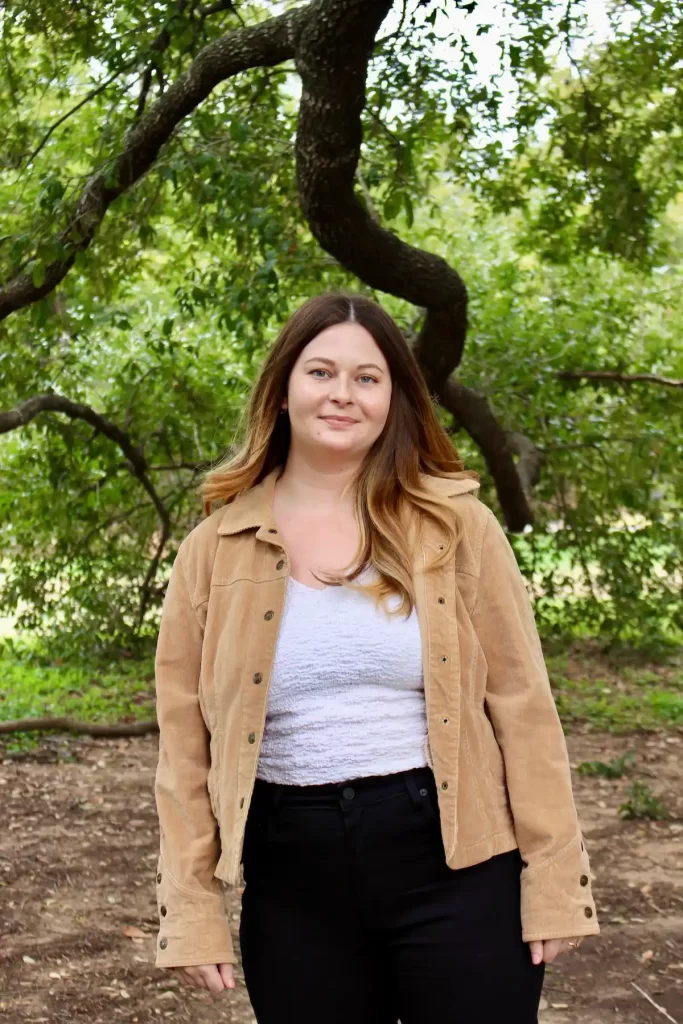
155, 542, 237, 967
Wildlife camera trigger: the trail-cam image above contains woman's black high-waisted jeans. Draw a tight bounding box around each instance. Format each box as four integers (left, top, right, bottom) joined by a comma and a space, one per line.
240, 768, 545, 1024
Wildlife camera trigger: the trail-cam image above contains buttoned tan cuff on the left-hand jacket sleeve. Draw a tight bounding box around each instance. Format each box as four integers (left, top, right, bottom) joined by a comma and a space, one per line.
155, 861, 238, 968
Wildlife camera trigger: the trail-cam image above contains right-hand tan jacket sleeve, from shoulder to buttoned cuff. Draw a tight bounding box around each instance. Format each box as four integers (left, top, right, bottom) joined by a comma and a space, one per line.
472, 509, 600, 942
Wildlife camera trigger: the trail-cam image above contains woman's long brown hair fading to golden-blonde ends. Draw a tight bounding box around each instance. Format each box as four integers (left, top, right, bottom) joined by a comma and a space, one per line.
201, 293, 478, 614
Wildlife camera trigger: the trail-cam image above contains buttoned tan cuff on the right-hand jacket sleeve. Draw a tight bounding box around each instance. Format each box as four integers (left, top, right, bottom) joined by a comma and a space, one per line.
521, 835, 600, 942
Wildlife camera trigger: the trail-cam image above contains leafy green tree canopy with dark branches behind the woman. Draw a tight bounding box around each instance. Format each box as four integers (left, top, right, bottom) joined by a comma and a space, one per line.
0, 0, 683, 645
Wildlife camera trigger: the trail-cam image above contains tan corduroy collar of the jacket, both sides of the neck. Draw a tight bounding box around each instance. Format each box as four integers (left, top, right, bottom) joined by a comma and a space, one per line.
217, 466, 479, 541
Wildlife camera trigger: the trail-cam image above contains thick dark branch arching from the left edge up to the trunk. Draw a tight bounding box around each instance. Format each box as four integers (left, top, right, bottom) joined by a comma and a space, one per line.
0, 7, 309, 322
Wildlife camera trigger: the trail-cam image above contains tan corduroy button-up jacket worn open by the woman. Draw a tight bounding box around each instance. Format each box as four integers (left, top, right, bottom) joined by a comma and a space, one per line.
156, 470, 600, 967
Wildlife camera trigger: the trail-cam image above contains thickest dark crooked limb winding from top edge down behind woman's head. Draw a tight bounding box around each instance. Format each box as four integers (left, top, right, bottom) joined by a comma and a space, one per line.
295, 0, 532, 529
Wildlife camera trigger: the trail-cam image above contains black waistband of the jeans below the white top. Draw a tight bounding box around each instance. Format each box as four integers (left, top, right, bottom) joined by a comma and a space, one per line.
254, 766, 435, 805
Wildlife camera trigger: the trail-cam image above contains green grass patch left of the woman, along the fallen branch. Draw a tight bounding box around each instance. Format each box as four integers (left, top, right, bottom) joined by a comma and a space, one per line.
0, 641, 155, 752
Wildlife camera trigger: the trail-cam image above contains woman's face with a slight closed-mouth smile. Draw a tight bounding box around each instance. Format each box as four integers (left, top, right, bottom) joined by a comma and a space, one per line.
286, 324, 391, 460
